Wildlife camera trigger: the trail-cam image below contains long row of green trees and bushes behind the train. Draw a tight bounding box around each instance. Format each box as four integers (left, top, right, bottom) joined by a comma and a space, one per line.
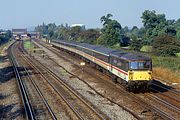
35, 10, 180, 56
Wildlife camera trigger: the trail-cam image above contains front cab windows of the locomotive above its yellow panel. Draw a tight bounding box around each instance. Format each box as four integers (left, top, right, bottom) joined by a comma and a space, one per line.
130, 61, 151, 70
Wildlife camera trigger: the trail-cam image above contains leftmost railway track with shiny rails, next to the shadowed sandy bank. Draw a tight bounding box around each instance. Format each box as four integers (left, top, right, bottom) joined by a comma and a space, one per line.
12, 42, 57, 120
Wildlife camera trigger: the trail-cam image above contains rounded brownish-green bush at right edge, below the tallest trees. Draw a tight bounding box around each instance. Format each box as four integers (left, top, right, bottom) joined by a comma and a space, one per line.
153, 34, 180, 56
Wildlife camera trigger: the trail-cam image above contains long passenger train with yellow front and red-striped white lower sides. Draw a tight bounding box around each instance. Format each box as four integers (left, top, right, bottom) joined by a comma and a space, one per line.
50, 40, 152, 91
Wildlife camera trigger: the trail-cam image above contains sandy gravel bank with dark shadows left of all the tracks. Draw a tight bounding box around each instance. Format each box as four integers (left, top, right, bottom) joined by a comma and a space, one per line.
0, 43, 25, 120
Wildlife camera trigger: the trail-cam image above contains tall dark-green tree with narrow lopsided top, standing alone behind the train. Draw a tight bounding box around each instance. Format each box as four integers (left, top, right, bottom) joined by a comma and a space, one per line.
97, 14, 121, 46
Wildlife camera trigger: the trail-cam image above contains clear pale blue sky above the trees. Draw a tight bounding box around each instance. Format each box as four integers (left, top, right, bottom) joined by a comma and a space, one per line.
0, 0, 180, 29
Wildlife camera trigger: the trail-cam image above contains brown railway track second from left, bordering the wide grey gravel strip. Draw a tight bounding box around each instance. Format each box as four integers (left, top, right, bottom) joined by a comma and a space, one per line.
22, 41, 110, 120
